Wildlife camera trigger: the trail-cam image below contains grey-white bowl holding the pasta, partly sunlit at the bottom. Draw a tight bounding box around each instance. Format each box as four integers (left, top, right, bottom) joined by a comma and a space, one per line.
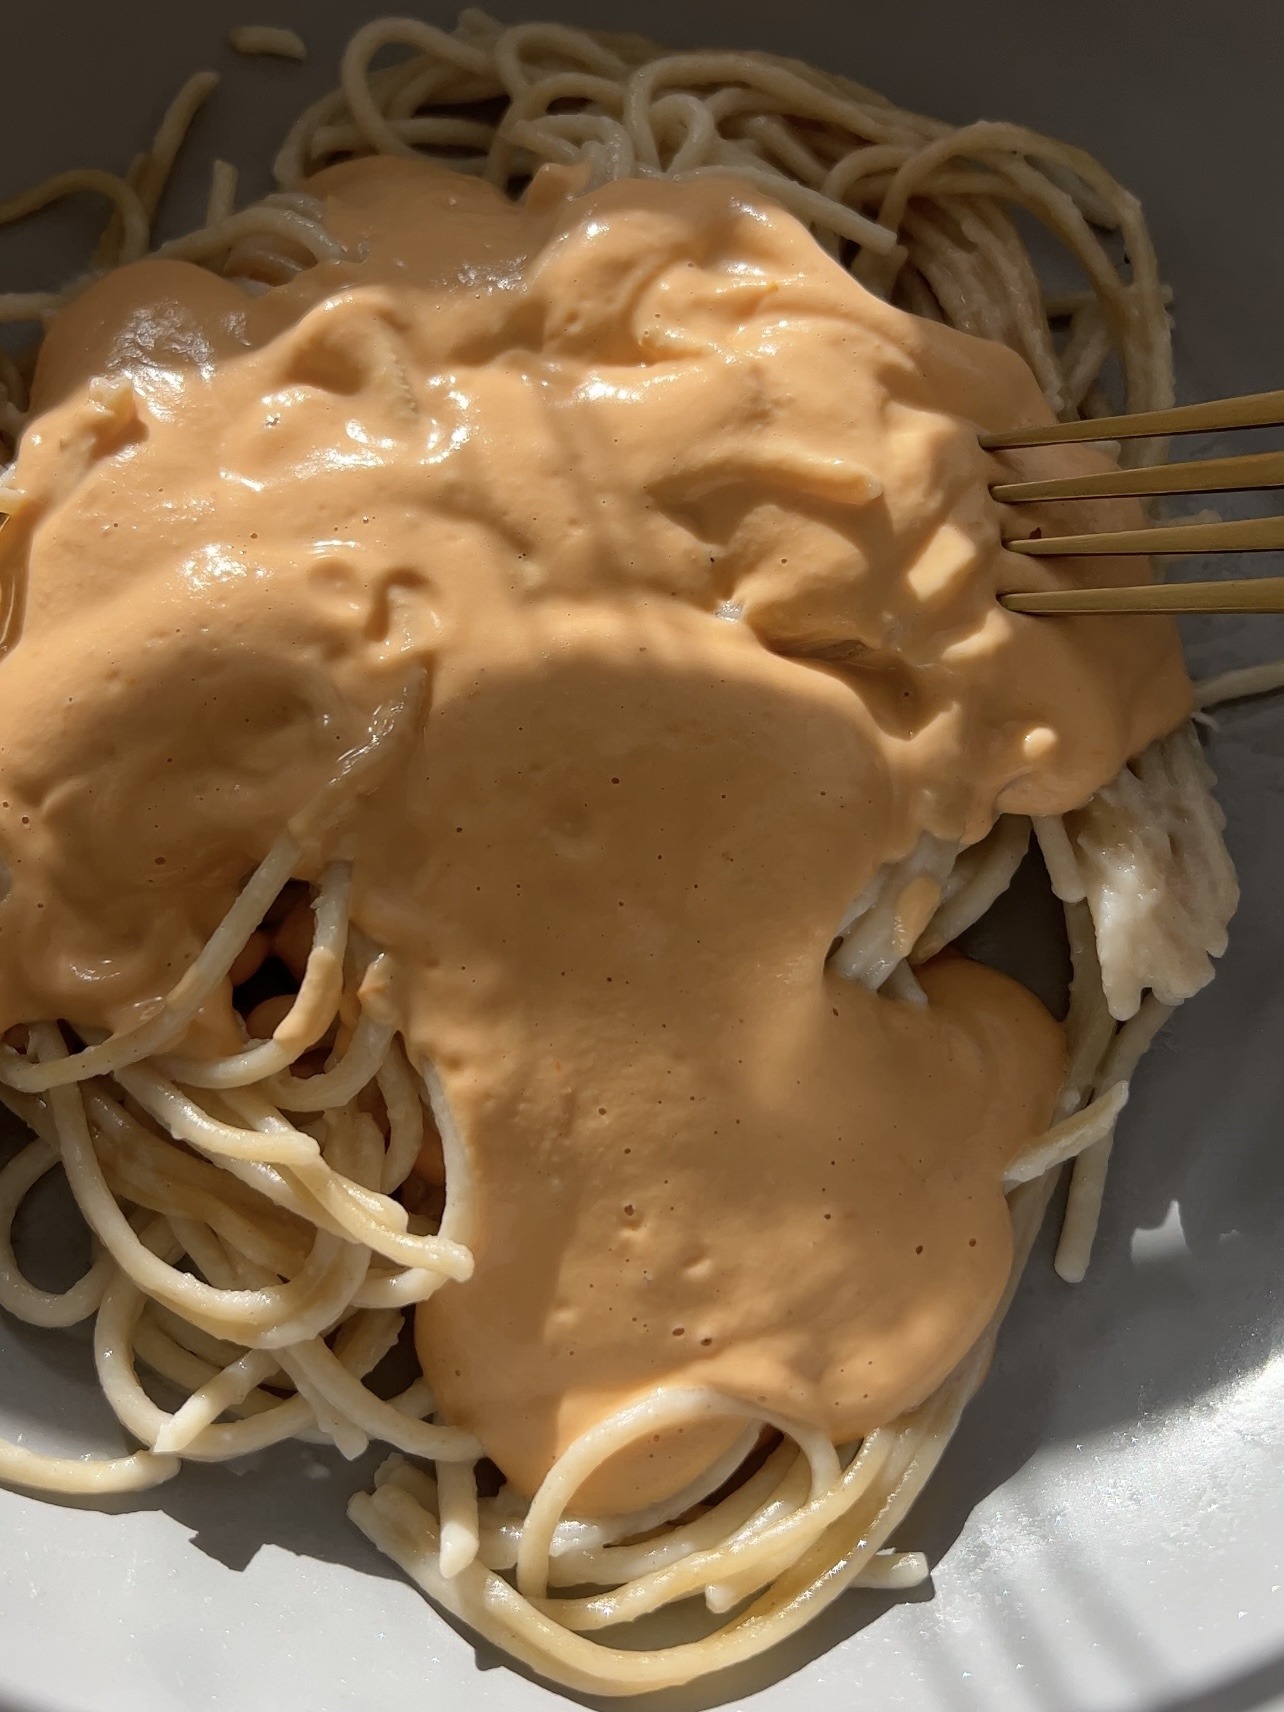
0, 0, 1284, 1712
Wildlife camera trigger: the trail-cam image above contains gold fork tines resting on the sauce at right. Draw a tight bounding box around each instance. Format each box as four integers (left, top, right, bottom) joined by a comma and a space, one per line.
981, 392, 1284, 613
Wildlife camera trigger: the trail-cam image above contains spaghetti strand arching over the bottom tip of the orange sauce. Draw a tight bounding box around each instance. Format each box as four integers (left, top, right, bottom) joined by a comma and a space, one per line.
517, 1385, 841, 1599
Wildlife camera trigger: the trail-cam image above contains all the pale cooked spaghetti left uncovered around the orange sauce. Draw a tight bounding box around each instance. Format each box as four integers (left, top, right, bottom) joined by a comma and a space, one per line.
0, 10, 1260, 1695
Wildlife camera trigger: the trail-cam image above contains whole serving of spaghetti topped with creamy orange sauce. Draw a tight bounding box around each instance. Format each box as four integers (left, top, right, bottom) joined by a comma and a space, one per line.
0, 12, 1236, 1695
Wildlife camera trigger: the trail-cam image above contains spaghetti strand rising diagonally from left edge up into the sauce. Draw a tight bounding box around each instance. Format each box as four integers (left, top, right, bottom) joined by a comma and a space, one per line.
0, 835, 301, 1094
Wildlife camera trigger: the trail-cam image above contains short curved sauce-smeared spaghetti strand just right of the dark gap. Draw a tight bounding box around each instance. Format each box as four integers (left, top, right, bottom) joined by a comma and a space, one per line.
161, 861, 353, 1088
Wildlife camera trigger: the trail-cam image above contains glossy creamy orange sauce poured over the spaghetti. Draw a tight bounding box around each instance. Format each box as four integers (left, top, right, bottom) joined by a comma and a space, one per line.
0, 161, 1190, 1508
